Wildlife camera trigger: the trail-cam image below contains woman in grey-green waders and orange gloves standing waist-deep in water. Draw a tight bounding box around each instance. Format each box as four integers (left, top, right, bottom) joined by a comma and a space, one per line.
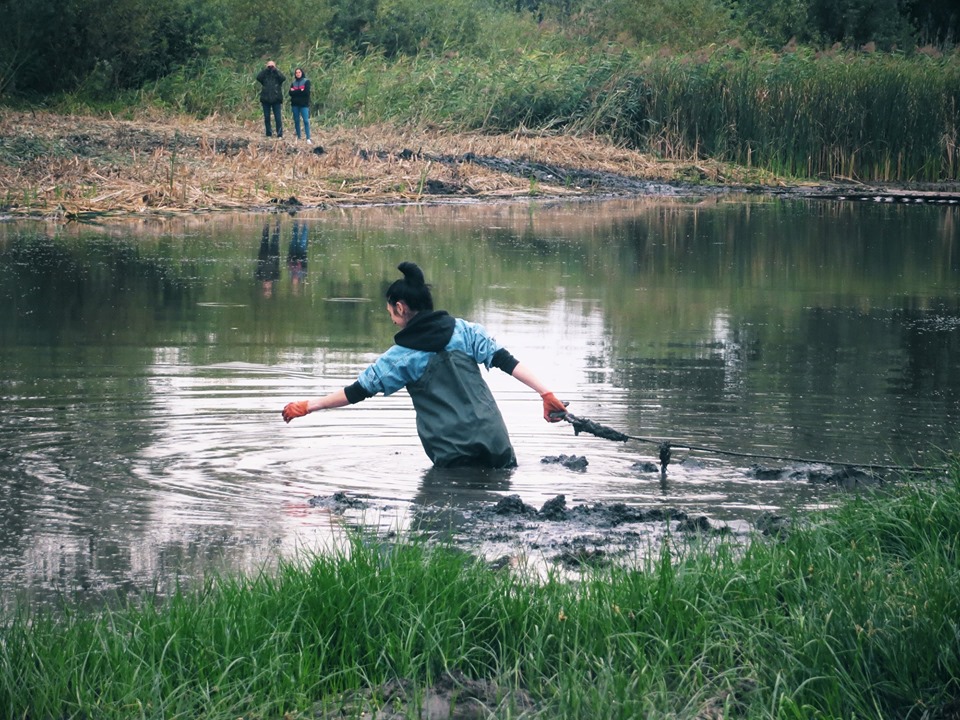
283, 262, 566, 468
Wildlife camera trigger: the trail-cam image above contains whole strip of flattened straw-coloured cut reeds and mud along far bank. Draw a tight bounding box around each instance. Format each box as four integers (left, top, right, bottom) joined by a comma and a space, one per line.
0, 109, 960, 220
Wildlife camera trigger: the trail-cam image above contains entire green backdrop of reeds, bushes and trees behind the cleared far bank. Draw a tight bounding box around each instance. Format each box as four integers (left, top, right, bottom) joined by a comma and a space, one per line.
0, 0, 960, 182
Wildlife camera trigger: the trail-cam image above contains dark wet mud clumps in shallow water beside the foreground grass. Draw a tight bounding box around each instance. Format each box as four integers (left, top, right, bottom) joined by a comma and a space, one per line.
309, 462, 892, 572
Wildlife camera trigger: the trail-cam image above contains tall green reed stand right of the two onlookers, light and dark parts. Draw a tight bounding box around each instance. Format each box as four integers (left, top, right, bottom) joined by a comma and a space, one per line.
296, 46, 960, 182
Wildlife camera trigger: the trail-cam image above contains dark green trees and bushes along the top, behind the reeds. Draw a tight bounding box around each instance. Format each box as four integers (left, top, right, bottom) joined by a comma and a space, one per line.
0, 0, 960, 100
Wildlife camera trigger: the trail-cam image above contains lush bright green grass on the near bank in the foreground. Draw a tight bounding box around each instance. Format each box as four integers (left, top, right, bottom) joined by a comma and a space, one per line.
0, 467, 960, 720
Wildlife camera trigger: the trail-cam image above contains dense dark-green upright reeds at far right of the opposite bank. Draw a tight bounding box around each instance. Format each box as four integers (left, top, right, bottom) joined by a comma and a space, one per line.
636, 47, 960, 181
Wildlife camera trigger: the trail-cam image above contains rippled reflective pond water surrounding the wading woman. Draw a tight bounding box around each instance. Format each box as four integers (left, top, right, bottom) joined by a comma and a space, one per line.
0, 197, 960, 608
